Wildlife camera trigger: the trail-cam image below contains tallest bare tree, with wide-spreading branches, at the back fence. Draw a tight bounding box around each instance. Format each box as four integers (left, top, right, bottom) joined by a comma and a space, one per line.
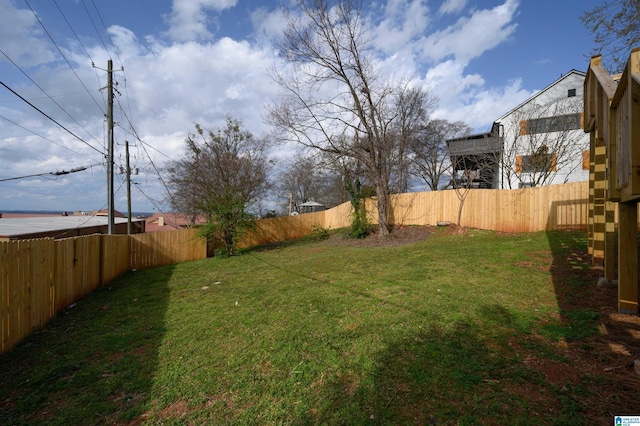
268, 0, 430, 237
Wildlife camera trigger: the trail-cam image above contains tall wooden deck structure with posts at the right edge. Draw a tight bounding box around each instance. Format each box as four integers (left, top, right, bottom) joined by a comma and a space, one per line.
584, 49, 640, 314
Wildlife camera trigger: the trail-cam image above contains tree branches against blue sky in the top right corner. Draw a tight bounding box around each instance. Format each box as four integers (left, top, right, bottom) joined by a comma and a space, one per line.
580, 0, 640, 72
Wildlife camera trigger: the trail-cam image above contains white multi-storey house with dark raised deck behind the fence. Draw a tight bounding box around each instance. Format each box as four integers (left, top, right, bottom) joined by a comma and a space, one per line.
447, 70, 589, 188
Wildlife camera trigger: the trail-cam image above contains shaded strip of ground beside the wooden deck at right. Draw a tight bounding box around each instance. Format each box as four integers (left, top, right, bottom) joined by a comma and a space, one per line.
538, 231, 640, 424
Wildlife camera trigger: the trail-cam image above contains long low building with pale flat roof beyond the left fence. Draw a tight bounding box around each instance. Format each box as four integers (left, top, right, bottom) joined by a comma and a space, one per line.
0, 216, 145, 241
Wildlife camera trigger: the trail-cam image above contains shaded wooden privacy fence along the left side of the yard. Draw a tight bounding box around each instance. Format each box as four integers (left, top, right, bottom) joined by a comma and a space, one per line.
0, 229, 207, 353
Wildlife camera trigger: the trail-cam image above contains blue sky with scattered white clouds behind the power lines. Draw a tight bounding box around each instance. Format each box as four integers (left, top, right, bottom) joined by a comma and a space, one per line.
0, 0, 600, 212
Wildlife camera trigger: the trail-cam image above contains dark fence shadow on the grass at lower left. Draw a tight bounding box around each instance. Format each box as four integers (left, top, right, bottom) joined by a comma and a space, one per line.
0, 266, 174, 425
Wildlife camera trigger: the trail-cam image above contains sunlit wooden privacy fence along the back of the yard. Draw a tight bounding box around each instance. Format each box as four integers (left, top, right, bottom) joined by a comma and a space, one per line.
240, 182, 589, 247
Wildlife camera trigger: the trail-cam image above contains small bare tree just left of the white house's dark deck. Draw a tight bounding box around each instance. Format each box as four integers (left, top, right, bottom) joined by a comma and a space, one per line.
411, 119, 471, 191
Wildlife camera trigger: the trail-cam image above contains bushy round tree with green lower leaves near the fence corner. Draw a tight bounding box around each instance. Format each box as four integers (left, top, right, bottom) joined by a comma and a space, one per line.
168, 117, 270, 254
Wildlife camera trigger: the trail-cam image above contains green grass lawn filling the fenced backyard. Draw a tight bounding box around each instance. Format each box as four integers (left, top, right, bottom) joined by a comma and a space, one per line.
0, 230, 640, 425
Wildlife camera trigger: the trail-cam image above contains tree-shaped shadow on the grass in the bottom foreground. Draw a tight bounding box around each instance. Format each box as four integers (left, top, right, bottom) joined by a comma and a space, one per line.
301, 305, 553, 425
